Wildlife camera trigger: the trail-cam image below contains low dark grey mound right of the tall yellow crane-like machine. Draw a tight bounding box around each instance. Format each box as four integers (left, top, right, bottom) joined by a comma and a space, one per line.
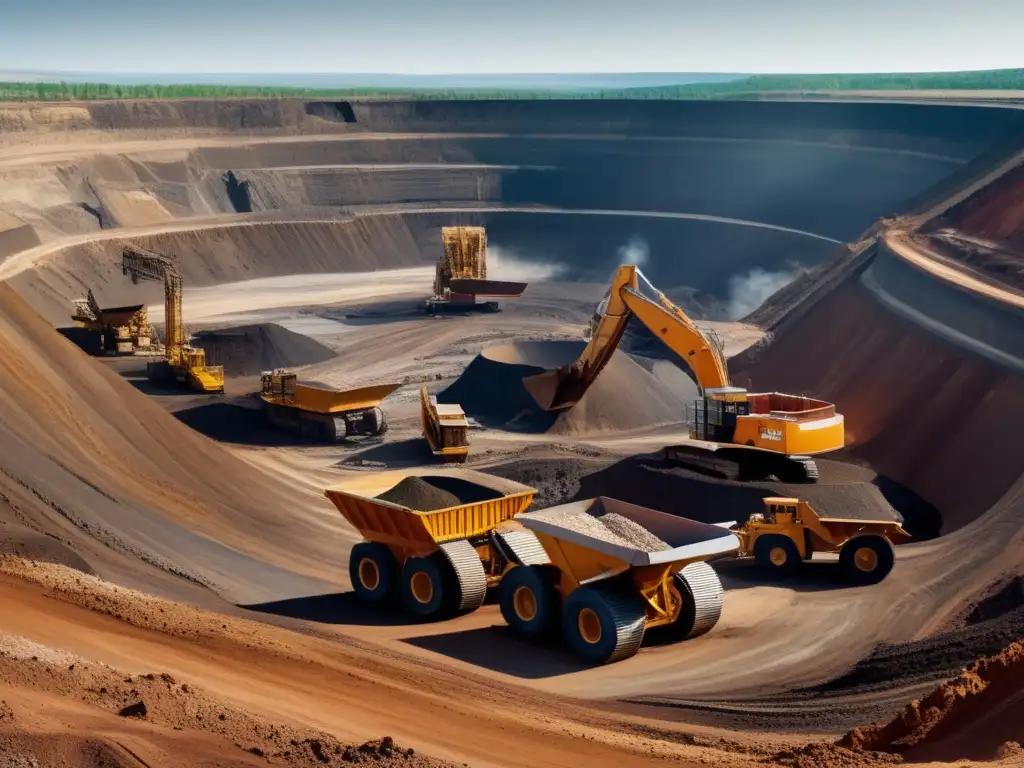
195, 323, 337, 376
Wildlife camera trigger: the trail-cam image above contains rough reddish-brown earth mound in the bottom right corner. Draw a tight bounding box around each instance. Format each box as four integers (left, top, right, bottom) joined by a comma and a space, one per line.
841, 642, 1024, 761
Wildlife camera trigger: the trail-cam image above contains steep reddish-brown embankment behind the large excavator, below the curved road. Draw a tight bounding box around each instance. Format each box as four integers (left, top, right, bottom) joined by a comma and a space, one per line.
731, 280, 1024, 531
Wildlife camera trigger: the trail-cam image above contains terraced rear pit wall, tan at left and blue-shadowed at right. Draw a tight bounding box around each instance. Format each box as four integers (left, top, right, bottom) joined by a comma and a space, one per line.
8, 100, 1024, 318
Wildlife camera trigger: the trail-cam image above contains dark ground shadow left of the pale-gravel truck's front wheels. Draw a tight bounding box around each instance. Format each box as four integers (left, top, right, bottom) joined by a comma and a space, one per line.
402, 626, 590, 680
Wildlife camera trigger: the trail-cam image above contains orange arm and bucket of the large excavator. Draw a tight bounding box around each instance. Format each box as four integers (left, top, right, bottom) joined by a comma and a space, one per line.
523, 264, 729, 411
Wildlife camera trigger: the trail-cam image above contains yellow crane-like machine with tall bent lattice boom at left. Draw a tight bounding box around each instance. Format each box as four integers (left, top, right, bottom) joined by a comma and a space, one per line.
121, 246, 224, 392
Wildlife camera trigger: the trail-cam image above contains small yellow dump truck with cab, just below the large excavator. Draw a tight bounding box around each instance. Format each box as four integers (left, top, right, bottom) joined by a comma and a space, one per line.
727, 497, 910, 585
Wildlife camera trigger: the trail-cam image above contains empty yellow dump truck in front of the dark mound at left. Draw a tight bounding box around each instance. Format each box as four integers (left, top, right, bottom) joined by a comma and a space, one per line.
260, 369, 400, 442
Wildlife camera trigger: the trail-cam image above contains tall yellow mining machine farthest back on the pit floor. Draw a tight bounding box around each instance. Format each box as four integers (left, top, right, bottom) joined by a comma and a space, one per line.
426, 226, 526, 313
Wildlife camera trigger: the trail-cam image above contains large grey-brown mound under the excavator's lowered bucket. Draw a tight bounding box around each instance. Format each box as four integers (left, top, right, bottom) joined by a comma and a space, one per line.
437, 341, 686, 434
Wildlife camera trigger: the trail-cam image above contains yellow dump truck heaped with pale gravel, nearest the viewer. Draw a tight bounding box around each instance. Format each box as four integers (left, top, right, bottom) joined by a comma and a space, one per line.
509, 497, 738, 664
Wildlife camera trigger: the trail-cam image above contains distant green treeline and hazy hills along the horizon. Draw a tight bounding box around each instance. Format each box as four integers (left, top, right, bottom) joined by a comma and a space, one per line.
0, 70, 1024, 101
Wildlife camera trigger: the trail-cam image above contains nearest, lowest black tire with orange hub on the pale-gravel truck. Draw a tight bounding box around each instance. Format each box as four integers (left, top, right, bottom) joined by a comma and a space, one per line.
562, 580, 647, 665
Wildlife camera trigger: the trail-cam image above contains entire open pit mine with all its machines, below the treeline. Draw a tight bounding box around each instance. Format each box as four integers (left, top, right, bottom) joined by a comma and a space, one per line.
0, 99, 1024, 768
